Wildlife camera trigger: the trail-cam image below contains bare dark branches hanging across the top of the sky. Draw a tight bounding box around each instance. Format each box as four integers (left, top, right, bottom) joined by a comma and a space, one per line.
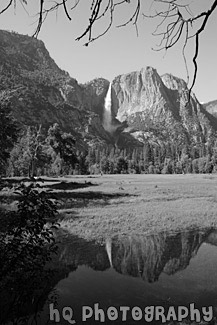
0, 0, 217, 91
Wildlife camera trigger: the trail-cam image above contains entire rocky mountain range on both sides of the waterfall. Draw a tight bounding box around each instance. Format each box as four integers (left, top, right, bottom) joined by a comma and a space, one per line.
0, 31, 217, 148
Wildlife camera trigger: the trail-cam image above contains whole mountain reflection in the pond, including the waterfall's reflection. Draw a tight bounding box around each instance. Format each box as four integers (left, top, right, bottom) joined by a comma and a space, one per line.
56, 229, 217, 282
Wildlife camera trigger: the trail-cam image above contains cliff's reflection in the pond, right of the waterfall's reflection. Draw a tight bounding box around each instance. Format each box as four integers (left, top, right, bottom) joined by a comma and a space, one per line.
107, 232, 206, 282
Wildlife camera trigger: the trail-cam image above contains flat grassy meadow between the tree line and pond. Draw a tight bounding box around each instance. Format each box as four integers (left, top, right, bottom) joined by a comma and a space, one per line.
49, 174, 217, 241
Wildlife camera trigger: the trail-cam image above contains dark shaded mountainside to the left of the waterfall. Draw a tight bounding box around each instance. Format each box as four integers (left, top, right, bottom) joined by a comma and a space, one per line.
0, 31, 142, 146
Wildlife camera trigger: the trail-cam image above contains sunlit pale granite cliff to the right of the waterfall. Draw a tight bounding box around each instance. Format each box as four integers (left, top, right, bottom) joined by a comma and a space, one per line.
112, 67, 217, 142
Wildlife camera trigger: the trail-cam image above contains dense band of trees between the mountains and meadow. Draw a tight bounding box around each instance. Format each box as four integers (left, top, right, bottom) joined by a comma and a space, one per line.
5, 119, 217, 176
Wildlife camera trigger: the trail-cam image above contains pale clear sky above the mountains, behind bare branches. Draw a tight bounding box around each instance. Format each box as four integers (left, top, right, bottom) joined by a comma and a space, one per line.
0, 0, 217, 102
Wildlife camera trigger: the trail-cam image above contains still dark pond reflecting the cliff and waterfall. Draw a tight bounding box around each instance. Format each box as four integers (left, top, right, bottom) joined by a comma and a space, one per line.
41, 229, 217, 324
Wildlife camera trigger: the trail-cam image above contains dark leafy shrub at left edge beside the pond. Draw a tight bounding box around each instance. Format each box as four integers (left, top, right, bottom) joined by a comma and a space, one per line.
0, 183, 58, 324
